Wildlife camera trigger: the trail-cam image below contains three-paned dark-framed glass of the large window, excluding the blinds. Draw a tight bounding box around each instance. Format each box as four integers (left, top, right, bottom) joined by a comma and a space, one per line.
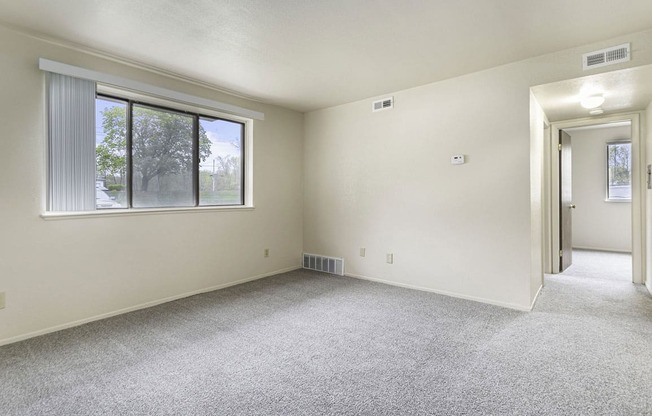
96, 95, 244, 209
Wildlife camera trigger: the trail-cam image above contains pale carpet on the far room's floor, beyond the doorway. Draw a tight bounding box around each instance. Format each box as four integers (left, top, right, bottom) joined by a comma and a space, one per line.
563, 248, 632, 282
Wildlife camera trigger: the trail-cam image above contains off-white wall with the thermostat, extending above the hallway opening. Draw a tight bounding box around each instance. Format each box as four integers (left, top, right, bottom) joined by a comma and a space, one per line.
304, 31, 652, 309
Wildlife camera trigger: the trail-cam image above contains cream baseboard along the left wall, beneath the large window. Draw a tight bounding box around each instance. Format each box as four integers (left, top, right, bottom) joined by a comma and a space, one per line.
0, 266, 301, 346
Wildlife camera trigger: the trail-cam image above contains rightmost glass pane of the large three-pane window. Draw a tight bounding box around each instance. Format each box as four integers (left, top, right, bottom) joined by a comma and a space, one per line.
199, 118, 244, 205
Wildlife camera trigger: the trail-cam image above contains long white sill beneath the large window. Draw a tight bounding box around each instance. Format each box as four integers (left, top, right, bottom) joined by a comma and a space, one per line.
41, 205, 254, 220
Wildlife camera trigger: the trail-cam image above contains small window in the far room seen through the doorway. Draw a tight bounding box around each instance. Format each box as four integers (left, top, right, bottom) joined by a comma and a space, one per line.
607, 141, 632, 201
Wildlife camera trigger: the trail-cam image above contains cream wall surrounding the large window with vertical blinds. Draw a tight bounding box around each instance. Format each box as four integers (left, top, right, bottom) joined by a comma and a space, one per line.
0, 27, 303, 344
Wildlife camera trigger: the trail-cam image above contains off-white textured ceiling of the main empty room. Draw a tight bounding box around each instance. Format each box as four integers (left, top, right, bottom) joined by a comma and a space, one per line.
0, 0, 652, 111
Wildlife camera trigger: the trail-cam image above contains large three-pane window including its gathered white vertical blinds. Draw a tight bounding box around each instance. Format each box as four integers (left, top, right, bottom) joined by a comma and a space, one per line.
48, 70, 245, 212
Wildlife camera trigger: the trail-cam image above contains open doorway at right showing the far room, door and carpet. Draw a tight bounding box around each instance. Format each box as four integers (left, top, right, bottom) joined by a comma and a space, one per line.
559, 120, 632, 282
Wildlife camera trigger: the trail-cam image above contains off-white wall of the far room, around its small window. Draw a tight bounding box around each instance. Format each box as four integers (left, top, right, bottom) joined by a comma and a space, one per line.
569, 126, 632, 252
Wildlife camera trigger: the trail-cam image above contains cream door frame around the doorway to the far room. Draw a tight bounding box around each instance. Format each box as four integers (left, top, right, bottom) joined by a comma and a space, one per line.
544, 112, 646, 284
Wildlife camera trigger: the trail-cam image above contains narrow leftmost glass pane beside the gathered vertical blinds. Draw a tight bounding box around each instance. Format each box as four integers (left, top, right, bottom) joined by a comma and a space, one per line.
95, 98, 128, 209
